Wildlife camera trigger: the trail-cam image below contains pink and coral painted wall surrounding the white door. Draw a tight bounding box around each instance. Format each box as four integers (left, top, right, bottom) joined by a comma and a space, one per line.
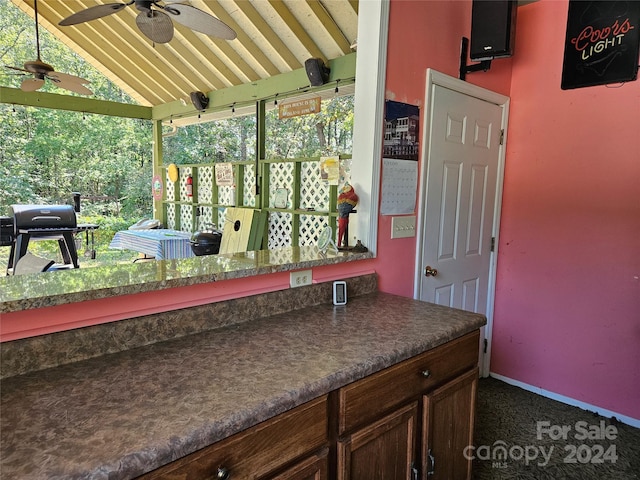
376, 0, 640, 419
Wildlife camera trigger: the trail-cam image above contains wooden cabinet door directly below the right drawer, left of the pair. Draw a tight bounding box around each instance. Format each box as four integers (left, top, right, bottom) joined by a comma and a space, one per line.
338, 402, 418, 480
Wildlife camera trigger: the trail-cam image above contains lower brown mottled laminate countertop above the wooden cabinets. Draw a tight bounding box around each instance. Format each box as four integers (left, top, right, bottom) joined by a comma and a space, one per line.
0, 293, 485, 480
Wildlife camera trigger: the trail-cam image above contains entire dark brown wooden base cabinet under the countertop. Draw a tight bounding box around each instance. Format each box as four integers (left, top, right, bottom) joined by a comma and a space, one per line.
141, 331, 479, 480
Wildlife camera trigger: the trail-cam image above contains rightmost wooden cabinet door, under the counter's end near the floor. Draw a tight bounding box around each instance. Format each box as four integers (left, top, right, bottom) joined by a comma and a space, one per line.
422, 368, 478, 480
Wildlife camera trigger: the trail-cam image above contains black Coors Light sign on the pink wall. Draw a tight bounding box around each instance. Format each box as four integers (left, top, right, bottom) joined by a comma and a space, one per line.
561, 0, 640, 90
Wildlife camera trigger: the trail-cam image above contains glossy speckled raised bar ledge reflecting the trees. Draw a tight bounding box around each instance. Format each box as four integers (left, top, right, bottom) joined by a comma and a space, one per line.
0, 246, 373, 314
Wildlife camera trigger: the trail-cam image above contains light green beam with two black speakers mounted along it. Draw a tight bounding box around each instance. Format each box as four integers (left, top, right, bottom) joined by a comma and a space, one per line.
153, 53, 356, 120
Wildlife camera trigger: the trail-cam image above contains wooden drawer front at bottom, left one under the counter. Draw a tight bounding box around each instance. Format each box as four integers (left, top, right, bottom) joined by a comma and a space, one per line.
140, 395, 328, 480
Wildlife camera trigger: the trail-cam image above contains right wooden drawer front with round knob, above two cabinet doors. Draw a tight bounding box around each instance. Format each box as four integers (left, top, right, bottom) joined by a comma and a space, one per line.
339, 330, 480, 435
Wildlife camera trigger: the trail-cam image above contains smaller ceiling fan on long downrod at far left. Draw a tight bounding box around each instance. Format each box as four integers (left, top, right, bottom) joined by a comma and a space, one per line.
5, 0, 93, 95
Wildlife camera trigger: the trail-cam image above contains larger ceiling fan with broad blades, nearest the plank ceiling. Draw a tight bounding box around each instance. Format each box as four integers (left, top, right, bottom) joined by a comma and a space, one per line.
58, 0, 237, 43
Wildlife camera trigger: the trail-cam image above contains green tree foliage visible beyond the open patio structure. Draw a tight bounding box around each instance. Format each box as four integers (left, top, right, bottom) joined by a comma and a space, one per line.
0, 0, 353, 225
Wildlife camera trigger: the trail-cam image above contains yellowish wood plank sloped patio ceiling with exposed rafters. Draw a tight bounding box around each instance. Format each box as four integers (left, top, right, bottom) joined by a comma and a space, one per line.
11, 0, 358, 106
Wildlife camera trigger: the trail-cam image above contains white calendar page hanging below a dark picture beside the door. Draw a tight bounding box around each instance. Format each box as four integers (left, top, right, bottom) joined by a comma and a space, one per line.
380, 158, 418, 215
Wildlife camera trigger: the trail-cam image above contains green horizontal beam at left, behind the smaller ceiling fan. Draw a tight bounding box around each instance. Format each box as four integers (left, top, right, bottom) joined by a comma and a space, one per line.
0, 87, 152, 120
